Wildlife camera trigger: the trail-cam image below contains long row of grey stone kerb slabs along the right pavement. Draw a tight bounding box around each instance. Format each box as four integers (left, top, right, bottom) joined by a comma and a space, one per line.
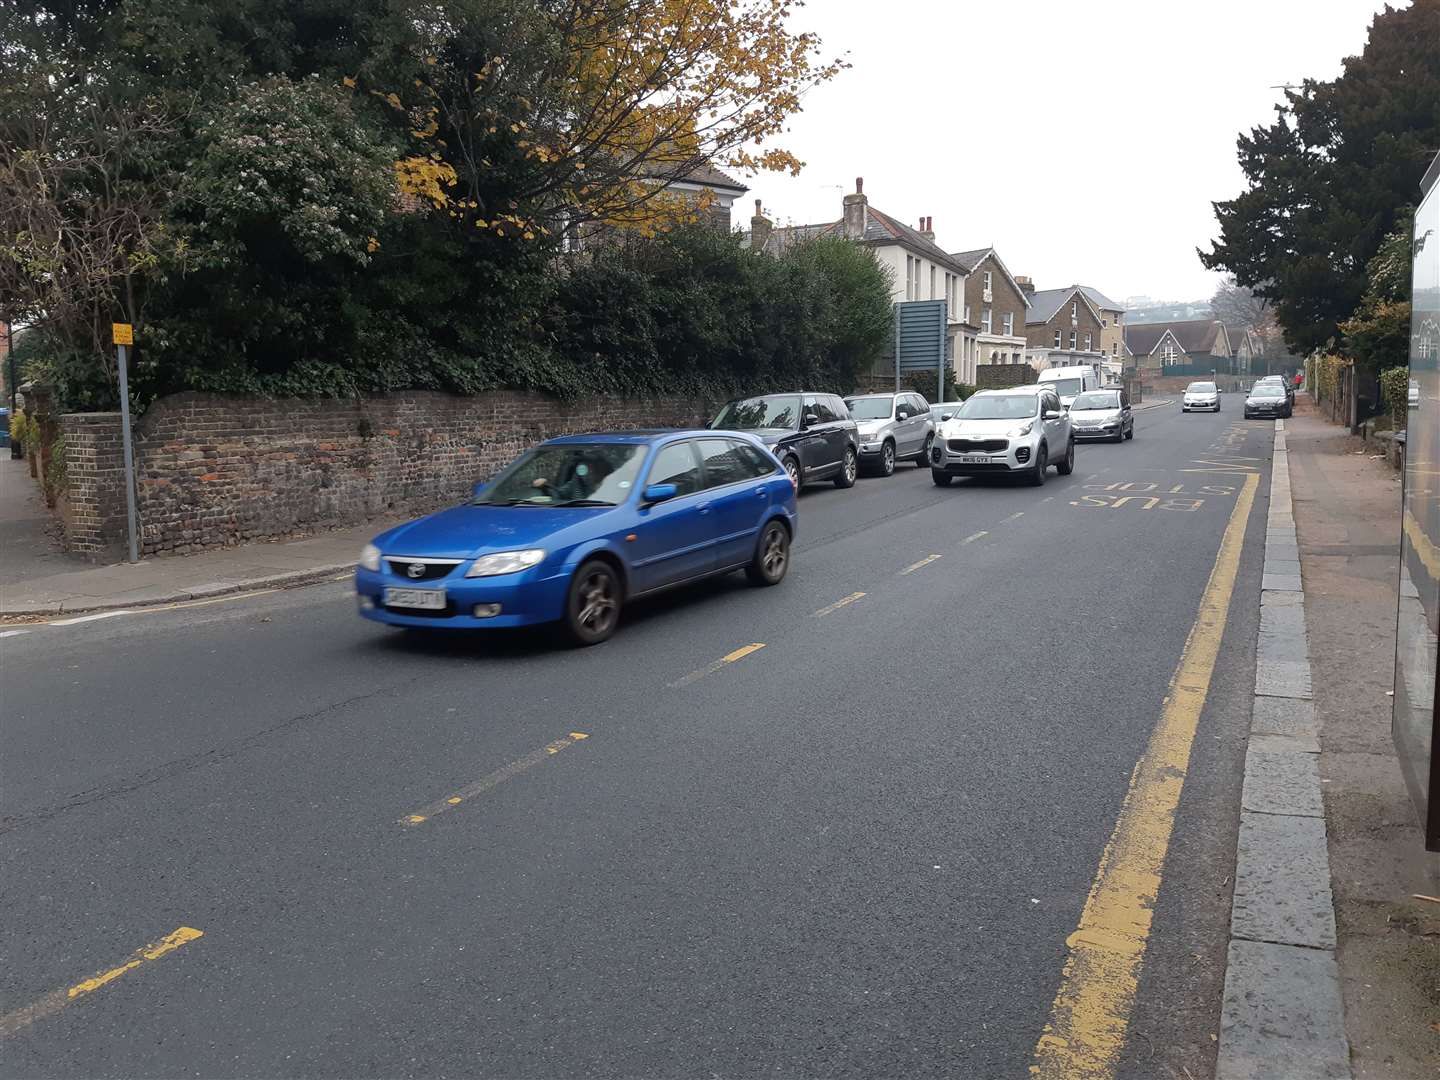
1215, 420, 1352, 1080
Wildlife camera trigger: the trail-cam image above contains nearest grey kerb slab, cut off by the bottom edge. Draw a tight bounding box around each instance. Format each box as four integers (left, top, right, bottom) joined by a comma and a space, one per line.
1215, 940, 1351, 1080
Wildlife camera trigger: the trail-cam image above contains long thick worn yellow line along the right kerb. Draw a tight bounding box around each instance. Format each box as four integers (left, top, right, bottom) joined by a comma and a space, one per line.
1030, 472, 1260, 1080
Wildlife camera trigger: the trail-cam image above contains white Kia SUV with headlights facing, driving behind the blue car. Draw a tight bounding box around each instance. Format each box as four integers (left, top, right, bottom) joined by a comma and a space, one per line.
930, 386, 1076, 488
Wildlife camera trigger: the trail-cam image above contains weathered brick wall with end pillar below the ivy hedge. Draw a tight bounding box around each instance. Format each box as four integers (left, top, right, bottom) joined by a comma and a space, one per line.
60, 392, 710, 557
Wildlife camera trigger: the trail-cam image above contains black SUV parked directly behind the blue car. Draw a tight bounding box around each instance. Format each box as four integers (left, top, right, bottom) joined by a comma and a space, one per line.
710, 393, 860, 491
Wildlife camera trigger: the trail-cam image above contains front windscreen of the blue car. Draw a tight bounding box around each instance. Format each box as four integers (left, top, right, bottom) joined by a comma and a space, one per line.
474, 442, 645, 507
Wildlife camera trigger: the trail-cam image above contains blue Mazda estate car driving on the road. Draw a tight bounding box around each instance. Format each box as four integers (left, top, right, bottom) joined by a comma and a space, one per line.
356, 431, 796, 645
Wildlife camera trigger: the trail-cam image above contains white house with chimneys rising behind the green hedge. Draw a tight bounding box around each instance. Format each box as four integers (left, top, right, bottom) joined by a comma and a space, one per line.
740, 177, 978, 383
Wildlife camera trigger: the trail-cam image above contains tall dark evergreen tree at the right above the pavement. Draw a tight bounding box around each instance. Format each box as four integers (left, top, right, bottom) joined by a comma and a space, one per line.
1200, 0, 1440, 353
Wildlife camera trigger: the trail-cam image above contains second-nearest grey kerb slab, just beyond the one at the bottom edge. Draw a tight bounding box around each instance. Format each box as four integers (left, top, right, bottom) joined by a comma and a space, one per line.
1230, 817, 1335, 949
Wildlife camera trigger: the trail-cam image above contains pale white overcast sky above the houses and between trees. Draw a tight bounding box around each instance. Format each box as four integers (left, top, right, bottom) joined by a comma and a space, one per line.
734, 0, 1408, 300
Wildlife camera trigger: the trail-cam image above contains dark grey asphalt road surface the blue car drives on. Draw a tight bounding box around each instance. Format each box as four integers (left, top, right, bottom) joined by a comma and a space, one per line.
0, 408, 1273, 1080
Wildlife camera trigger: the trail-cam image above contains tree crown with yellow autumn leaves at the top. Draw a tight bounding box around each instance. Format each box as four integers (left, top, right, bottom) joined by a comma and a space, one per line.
383, 0, 845, 242
